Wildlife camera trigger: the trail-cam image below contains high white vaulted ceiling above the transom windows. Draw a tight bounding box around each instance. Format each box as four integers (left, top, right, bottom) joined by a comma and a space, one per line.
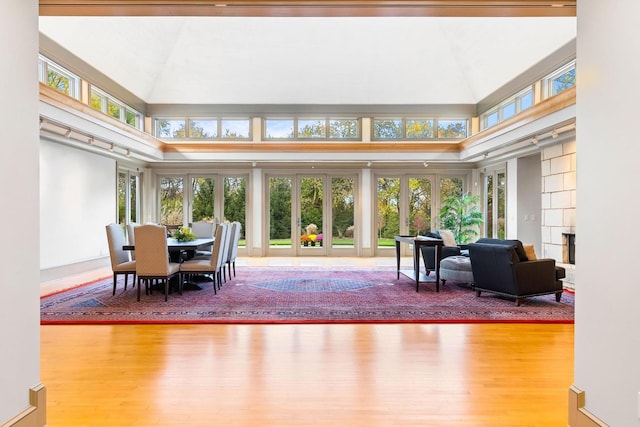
40, 16, 576, 104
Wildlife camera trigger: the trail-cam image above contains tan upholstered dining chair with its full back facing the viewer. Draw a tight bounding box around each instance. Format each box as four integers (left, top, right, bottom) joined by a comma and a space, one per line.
134, 224, 180, 301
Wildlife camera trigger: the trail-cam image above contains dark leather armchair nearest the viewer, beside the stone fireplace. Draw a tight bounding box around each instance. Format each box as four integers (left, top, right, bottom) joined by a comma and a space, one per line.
468, 239, 565, 306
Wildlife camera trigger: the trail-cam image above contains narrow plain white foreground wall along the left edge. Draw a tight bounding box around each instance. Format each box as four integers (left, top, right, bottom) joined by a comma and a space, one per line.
0, 0, 40, 424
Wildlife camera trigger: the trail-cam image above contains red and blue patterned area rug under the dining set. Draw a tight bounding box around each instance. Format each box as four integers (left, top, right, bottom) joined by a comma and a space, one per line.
40, 267, 574, 324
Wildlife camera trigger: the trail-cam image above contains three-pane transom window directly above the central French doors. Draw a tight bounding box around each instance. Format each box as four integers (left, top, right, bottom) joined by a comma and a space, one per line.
263, 118, 360, 140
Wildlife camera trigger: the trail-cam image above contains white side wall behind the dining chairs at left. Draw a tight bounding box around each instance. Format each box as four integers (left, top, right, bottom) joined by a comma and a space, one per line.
40, 139, 117, 270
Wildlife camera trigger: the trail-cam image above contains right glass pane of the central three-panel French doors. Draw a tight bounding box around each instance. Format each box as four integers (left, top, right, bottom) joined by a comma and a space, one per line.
331, 178, 355, 248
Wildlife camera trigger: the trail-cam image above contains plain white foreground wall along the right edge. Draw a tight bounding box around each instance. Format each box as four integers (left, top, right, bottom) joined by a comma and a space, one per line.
574, 0, 640, 427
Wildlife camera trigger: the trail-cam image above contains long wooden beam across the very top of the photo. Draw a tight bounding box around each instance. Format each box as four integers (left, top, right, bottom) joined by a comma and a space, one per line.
40, 0, 577, 17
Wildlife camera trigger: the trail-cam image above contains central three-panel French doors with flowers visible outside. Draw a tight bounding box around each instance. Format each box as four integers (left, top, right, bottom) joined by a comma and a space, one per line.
265, 174, 356, 256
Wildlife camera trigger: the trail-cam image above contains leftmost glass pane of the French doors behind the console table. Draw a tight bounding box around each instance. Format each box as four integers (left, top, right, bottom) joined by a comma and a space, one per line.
376, 178, 400, 247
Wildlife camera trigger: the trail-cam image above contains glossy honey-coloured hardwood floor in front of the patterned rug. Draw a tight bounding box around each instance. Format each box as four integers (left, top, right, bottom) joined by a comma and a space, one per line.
41, 324, 574, 427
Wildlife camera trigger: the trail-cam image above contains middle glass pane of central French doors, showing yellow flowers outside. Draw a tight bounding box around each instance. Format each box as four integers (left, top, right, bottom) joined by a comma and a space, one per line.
300, 178, 324, 246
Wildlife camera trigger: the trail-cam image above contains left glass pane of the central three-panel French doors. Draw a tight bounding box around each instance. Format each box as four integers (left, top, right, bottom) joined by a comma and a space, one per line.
269, 177, 291, 247
